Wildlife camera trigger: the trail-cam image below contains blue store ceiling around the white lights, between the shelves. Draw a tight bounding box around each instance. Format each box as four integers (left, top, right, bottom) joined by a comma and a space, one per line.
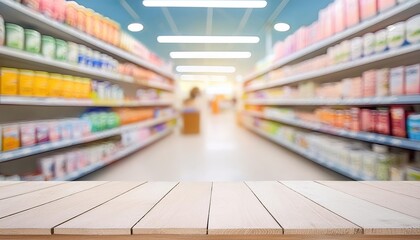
76, 0, 333, 75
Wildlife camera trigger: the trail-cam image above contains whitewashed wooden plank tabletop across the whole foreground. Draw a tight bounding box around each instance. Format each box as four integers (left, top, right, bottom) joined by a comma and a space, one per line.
0, 181, 420, 240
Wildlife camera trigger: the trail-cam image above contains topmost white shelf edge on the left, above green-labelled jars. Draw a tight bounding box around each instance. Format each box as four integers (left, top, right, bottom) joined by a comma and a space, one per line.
0, 0, 174, 79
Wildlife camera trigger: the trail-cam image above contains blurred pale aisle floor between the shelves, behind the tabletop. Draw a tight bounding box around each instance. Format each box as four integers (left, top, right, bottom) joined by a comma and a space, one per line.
81, 112, 348, 181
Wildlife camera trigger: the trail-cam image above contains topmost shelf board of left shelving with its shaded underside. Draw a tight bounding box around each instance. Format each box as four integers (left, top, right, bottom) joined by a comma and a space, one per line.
0, 0, 174, 79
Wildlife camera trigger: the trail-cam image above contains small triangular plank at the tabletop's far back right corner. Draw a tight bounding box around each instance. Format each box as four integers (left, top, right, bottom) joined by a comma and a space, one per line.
361, 181, 420, 198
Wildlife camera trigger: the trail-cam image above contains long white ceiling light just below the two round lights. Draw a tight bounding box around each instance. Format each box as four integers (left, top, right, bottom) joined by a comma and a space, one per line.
157, 36, 260, 43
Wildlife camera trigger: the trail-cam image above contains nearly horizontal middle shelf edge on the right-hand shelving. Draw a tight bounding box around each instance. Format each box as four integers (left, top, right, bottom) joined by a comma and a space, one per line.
245, 95, 420, 106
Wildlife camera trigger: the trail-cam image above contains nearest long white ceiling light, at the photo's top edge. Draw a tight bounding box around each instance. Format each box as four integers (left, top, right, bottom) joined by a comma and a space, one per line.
143, 0, 267, 8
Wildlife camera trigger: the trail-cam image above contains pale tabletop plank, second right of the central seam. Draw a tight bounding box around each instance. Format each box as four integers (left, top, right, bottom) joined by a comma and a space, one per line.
246, 182, 362, 235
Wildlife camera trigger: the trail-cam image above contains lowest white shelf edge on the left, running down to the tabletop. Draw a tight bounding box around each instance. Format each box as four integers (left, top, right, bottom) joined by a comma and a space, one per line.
52, 128, 173, 181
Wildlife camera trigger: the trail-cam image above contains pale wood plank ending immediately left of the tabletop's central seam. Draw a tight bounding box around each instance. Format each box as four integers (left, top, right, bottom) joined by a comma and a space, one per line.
133, 182, 212, 234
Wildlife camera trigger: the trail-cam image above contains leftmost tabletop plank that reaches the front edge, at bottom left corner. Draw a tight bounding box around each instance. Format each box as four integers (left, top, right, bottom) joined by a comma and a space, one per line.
0, 182, 141, 235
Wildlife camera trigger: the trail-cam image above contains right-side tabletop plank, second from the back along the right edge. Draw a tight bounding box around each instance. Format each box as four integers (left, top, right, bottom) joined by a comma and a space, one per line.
319, 181, 420, 219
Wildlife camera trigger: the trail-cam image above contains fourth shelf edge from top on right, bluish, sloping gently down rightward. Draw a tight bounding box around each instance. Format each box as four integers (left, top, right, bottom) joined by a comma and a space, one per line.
245, 111, 420, 151
